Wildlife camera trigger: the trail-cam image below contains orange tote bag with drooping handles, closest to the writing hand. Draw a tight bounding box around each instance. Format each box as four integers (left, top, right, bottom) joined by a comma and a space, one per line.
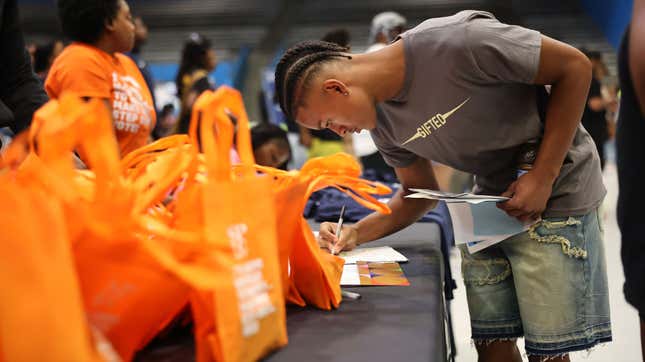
256, 153, 390, 310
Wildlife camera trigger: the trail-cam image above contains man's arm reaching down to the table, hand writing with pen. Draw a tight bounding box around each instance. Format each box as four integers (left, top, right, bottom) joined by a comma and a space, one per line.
319, 158, 438, 251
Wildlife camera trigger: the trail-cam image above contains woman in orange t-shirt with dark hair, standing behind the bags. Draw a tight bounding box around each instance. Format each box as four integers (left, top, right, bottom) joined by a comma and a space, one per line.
45, 0, 156, 156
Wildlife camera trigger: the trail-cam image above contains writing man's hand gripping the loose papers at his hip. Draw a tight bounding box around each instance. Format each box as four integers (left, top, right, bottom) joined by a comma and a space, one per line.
497, 171, 553, 222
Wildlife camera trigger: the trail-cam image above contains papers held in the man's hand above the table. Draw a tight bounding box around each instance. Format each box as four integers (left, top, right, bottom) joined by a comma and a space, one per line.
406, 189, 532, 254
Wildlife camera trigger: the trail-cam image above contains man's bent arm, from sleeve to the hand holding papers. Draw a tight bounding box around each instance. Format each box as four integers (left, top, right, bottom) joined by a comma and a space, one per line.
500, 36, 591, 220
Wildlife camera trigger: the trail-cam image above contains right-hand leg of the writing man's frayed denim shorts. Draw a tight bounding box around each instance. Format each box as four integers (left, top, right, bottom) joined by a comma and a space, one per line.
500, 210, 611, 361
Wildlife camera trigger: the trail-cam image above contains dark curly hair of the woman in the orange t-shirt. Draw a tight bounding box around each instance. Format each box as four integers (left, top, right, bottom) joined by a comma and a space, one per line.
57, 0, 121, 44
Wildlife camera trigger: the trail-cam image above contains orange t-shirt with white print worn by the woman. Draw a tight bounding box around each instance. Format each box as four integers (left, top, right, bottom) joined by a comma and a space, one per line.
45, 43, 156, 157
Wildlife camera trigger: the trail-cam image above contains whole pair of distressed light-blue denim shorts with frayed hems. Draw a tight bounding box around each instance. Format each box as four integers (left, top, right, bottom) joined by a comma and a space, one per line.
461, 210, 611, 357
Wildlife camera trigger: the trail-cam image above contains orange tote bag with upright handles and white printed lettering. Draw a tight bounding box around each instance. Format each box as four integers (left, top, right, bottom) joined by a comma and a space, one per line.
186, 87, 287, 361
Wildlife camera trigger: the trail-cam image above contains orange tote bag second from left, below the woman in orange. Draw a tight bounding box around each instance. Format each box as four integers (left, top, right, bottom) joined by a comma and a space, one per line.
25, 95, 192, 360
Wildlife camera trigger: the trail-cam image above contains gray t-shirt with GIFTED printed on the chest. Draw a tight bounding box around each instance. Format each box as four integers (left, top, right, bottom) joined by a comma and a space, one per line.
371, 11, 606, 217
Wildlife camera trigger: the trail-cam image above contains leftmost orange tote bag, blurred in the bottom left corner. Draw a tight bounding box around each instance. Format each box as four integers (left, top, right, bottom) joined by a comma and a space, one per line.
0, 182, 101, 362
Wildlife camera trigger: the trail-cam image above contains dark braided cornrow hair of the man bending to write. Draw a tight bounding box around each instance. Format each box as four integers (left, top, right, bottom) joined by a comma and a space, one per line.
275, 41, 352, 119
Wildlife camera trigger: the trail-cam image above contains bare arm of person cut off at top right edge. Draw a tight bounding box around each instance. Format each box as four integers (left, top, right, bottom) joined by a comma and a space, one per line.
629, 0, 645, 114
